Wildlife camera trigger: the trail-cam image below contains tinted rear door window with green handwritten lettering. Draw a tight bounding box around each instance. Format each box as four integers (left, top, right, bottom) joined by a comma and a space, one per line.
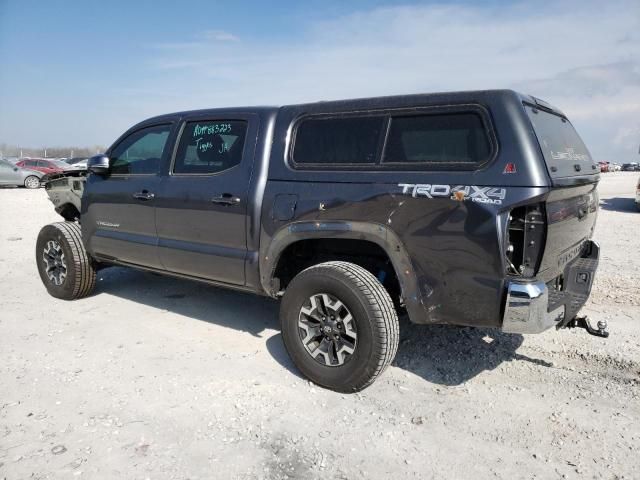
173, 120, 247, 175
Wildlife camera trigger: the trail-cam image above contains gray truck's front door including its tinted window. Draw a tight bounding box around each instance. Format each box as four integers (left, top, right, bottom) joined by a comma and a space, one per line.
81, 124, 172, 268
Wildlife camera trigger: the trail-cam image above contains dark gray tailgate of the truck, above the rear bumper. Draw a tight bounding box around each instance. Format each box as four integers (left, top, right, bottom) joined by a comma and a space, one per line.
538, 183, 598, 282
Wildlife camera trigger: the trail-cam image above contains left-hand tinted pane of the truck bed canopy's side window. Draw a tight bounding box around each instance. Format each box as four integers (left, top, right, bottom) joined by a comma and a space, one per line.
293, 116, 385, 166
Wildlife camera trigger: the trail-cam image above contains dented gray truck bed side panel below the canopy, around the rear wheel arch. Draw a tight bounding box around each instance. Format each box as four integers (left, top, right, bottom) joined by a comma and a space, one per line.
261, 178, 546, 326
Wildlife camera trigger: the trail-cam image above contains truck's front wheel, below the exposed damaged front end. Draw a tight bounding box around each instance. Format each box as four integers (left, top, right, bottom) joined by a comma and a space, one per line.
36, 222, 96, 300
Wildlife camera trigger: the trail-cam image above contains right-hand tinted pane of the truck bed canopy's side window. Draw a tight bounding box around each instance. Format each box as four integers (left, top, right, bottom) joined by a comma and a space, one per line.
383, 113, 491, 168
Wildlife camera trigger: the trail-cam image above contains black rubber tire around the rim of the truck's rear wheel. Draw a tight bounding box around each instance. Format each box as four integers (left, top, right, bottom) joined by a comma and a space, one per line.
280, 261, 400, 393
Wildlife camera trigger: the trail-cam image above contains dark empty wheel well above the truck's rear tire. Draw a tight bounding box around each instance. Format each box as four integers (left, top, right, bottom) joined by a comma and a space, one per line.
273, 238, 402, 306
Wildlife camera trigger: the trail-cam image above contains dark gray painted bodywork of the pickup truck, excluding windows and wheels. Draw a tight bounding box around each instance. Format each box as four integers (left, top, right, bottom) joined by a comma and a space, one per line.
77, 90, 598, 327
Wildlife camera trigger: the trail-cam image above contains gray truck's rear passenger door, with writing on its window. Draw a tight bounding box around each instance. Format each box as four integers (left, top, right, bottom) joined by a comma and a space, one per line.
156, 114, 258, 285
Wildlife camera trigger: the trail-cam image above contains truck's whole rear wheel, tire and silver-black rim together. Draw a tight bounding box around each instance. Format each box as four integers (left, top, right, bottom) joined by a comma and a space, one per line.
280, 262, 400, 392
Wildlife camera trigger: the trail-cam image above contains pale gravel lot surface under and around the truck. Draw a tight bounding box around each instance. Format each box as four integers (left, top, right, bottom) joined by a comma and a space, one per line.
0, 173, 640, 479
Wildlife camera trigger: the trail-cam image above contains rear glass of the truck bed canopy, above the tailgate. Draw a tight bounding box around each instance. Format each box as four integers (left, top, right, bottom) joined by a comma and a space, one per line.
525, 105, 598, 178
